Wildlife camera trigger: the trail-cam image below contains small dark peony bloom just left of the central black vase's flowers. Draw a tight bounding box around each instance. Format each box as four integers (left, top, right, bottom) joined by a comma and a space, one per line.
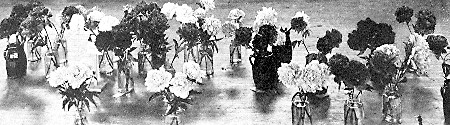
234, 27, 253, 47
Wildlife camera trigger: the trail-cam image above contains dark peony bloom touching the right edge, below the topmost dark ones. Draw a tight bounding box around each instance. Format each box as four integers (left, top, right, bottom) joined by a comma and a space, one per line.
427, 35, 448, 57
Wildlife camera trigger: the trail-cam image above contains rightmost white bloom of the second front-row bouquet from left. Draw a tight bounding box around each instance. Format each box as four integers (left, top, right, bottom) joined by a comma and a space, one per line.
182, 61, 206, 83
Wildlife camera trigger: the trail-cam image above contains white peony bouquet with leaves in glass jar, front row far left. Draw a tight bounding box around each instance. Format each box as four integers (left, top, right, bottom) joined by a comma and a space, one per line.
47, 64, 100, 125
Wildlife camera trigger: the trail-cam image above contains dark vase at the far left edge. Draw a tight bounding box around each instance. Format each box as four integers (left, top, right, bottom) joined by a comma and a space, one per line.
3, 43, 27, 78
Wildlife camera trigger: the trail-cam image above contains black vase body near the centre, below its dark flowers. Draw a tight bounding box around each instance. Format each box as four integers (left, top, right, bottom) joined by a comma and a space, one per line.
250, 54, 280, 91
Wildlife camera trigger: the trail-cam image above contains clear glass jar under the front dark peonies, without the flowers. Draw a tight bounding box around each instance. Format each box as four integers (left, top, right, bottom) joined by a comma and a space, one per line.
344, 98, 364, 125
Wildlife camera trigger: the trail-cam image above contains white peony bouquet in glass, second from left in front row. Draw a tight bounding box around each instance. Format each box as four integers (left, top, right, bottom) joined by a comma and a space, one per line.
145, 61, 206, 116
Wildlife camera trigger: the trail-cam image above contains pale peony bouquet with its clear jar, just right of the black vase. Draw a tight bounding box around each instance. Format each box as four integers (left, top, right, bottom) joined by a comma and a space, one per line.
277, 60, 330, 125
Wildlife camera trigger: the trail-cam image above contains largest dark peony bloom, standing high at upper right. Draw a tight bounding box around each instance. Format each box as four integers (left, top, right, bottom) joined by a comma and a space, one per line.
347, 18, 395, 52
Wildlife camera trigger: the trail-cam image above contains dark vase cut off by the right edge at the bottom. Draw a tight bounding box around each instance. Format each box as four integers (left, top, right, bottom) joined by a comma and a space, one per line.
441, 79, 450, 125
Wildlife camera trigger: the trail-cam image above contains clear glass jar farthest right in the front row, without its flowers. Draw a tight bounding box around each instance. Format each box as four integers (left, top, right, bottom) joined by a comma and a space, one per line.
382, 83, 402, 124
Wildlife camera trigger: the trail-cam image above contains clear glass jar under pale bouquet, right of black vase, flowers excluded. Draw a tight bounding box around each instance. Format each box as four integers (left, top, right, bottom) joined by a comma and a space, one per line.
291, 92, 312, 125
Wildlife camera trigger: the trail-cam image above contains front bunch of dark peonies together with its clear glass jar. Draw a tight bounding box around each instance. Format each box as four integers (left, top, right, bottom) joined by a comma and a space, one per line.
328, 54, 373, 125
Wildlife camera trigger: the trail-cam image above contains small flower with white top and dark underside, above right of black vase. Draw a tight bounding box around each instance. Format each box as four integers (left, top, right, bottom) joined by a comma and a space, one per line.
291, 11, 309, 32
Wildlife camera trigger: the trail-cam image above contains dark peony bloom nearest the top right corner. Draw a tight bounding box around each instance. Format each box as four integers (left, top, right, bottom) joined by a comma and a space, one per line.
413, 10, 436, 35
